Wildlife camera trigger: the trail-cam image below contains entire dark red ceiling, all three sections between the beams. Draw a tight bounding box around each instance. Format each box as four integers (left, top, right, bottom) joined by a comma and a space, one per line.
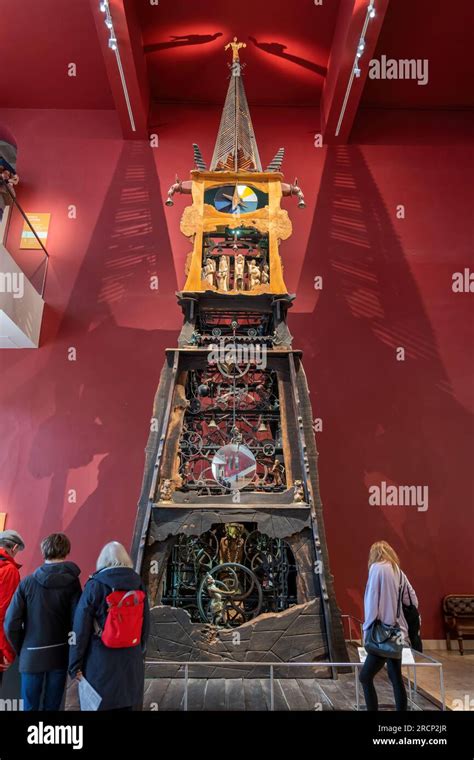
0, 0, 474, 118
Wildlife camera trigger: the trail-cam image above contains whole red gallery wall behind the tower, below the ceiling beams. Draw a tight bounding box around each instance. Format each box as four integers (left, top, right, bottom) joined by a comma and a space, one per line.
0, 106, 474, 638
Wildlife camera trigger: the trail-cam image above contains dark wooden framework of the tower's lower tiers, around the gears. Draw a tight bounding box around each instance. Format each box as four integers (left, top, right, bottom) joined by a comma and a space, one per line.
133, 297, 347, 678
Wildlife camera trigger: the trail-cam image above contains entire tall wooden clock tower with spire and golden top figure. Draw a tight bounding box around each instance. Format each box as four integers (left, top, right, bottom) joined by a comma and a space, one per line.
133, 38, 347, 677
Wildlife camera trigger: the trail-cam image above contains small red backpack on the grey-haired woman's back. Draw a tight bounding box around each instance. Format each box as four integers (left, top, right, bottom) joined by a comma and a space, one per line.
97, 591, 145, 649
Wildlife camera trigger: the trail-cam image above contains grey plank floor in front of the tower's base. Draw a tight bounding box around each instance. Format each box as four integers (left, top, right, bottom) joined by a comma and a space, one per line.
143, 674, 439, 711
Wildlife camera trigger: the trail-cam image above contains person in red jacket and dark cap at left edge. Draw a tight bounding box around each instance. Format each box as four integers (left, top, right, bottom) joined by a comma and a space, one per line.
0, 530, 25, 684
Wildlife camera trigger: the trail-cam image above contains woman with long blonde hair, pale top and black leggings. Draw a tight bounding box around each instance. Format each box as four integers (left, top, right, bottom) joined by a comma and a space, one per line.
359, 541, 418, 711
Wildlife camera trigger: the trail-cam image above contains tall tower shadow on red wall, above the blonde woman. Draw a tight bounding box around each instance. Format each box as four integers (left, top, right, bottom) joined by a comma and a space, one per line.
290, 146, 473, 638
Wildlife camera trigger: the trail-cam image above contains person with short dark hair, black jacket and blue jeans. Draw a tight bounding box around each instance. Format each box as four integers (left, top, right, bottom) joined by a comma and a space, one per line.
5, 533, 81, 711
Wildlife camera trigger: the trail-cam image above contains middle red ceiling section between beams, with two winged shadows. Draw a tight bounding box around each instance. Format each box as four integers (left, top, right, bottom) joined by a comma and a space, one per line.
132, 0, 342, 105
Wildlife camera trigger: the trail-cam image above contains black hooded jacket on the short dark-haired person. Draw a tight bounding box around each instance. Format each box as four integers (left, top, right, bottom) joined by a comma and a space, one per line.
5, 562, 81, 673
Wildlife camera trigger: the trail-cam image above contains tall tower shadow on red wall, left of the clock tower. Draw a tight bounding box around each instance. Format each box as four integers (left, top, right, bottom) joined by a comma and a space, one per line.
29, 142, 179, 570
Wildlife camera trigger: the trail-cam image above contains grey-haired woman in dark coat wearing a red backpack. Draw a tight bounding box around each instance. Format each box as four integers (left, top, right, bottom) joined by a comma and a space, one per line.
69, 541, 149, 710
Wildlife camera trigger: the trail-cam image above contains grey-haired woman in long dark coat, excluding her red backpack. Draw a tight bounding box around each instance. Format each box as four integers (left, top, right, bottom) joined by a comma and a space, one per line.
69, 541, 149, 710
